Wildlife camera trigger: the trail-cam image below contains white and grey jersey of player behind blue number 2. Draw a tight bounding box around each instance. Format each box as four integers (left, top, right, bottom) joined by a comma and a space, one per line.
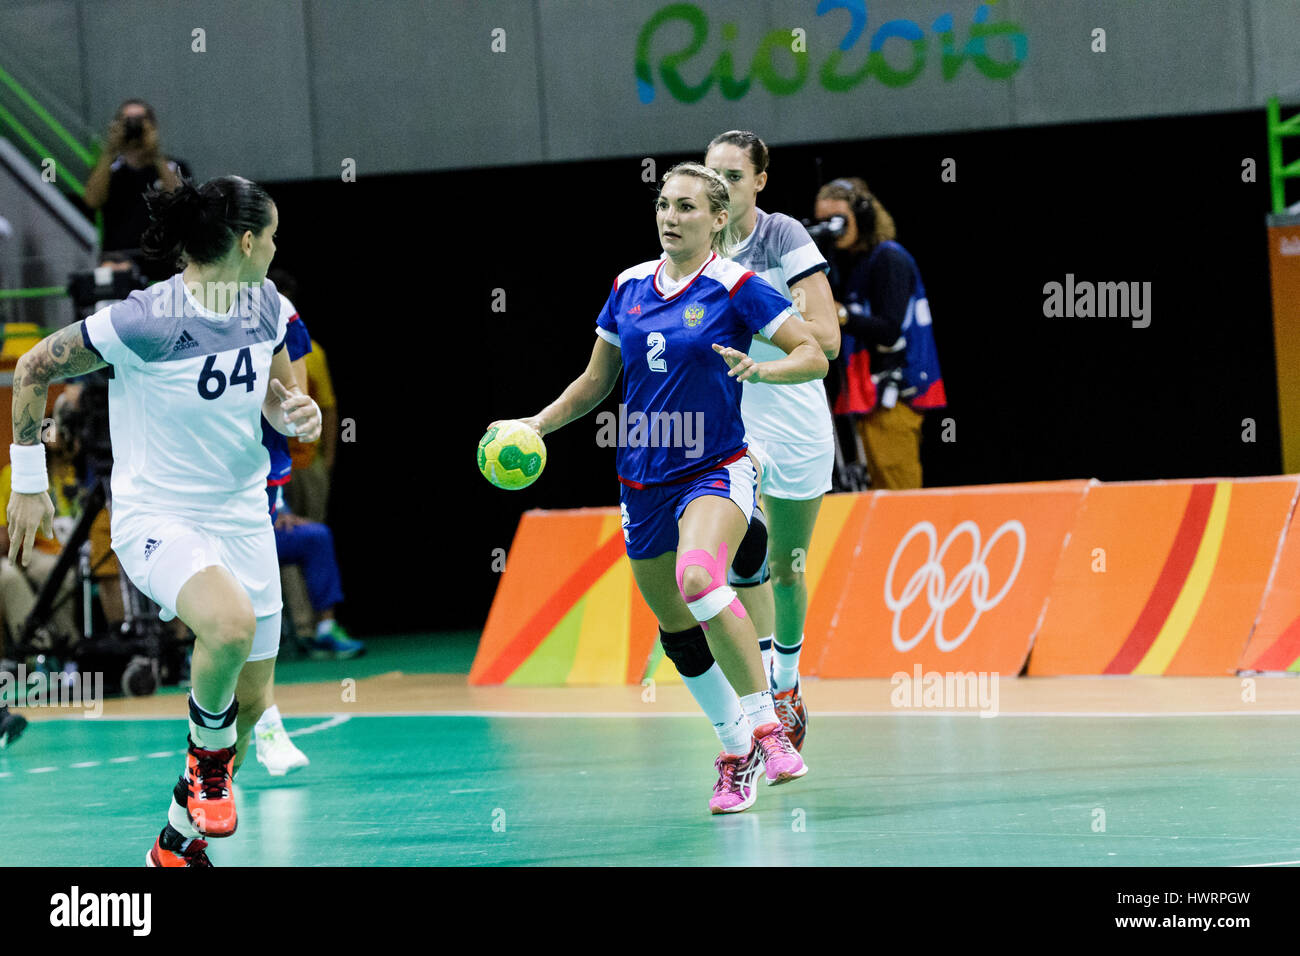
731, 209, 833, 445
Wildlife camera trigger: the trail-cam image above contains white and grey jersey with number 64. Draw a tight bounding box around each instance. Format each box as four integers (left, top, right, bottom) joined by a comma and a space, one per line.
83, 273, 287, 535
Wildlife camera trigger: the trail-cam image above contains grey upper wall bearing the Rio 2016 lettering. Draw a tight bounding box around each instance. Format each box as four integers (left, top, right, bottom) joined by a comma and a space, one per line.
0, 0, 1300, 179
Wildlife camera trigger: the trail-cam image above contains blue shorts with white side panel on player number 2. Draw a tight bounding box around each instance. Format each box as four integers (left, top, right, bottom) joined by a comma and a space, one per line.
619, 455, 758, 561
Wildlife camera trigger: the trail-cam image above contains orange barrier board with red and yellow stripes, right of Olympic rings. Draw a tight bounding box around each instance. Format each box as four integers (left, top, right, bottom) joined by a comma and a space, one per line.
1028, 476, 1300, 676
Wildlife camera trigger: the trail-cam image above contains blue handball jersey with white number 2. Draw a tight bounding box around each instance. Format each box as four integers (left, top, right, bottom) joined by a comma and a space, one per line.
595, 255, 792, 488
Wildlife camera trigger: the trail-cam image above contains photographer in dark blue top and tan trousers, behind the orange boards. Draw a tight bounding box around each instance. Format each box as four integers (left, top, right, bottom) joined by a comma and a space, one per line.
809, 178, 948, 490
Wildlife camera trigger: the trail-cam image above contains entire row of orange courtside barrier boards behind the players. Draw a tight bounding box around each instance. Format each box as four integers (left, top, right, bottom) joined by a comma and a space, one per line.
469, 476, 1300, 684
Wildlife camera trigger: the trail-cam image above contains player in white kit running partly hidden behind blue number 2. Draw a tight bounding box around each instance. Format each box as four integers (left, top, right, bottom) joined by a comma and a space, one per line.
705, 130, 840, 749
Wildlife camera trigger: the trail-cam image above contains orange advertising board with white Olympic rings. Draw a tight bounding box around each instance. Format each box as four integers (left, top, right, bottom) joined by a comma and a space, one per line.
805, 481, 1089, 678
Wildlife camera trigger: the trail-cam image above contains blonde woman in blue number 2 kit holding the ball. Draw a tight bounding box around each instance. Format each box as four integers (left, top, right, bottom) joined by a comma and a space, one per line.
496, 163, 827, 813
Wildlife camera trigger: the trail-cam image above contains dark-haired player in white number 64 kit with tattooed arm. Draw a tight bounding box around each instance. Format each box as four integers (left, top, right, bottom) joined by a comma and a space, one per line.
9, 176, 321, 866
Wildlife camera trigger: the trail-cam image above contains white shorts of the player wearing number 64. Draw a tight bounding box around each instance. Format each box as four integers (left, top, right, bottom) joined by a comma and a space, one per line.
112, 512, 283, 661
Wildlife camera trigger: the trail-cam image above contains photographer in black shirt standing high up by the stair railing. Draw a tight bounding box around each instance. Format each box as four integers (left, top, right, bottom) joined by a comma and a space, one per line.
86, 99, 191, 280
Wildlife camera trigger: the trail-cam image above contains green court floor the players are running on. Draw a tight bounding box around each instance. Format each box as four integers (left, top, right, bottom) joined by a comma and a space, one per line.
0, 713, 1300, 866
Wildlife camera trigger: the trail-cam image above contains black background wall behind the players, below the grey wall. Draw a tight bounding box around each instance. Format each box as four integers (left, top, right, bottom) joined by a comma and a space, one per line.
267, 111, 1281, 633
